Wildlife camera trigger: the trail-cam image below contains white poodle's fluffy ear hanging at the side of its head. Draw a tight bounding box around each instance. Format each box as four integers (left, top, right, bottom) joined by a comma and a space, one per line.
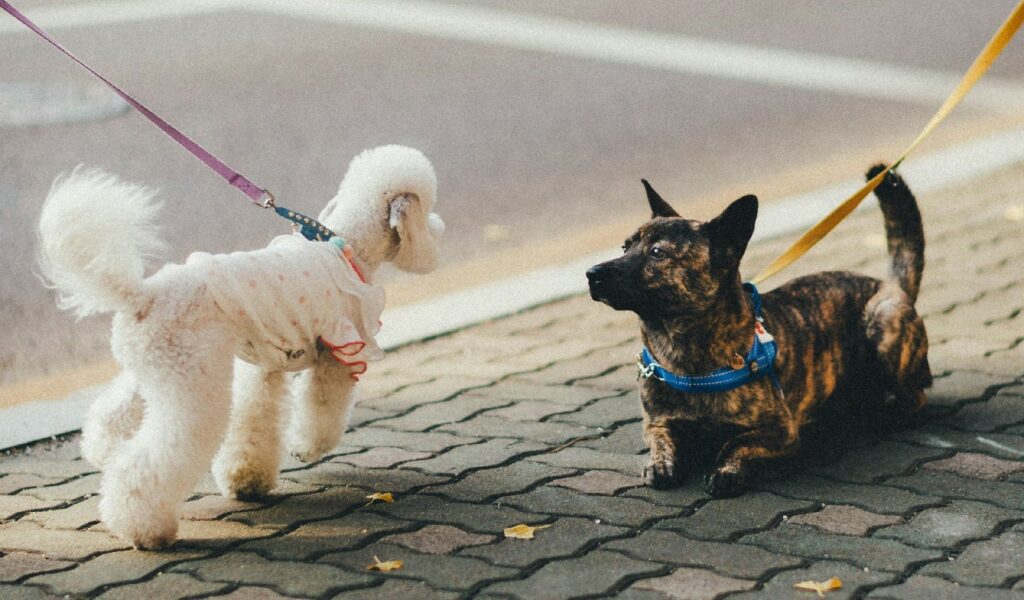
388, 194, 444, 273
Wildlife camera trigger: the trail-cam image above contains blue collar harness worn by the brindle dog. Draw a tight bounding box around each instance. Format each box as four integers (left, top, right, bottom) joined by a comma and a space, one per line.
637, 284, 780, 392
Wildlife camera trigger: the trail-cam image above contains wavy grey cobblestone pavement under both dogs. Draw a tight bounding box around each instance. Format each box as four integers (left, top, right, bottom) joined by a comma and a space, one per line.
0, 166, 1024, 600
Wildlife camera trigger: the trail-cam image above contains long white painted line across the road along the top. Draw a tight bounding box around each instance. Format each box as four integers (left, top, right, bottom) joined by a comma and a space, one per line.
6, 0, 1024, 112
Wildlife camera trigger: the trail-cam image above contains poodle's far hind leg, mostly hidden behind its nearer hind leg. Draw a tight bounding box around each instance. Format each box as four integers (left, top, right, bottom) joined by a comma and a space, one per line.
81, 371, 144, 468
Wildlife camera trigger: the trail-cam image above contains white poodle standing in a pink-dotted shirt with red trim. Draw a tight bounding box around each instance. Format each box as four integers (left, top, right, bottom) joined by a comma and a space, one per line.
39, 145, 444, 548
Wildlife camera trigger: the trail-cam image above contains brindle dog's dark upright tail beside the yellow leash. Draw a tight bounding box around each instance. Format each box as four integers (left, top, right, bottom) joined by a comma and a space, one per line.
867, 164, 925, 303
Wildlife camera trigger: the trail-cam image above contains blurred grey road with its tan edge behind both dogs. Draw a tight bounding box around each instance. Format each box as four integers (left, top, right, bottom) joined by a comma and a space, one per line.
6, 0, 1024, 404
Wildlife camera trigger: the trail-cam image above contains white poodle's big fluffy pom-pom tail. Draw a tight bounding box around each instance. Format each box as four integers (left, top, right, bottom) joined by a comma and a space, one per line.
39, 167, 164, 316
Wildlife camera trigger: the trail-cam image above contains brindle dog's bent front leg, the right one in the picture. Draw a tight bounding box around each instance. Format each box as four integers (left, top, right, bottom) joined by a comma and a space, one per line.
705, 416, 799, 498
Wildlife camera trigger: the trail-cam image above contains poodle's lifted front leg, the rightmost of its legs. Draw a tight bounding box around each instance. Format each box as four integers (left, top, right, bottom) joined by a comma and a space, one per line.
288, 355, 356, 463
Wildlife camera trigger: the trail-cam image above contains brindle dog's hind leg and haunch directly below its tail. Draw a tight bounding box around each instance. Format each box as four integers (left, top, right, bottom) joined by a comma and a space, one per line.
864, 282, 932, 415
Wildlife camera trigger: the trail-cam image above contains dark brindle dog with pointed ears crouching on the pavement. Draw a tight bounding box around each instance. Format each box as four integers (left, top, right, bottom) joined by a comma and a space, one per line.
587, 165, 932, 498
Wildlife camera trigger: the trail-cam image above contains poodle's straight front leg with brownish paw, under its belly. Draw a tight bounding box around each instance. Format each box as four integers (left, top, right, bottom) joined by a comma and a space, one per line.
213, 359, 285, 500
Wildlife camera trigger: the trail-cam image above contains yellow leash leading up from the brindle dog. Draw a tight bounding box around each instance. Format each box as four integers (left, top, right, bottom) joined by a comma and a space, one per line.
752, 0, 1024, 284
